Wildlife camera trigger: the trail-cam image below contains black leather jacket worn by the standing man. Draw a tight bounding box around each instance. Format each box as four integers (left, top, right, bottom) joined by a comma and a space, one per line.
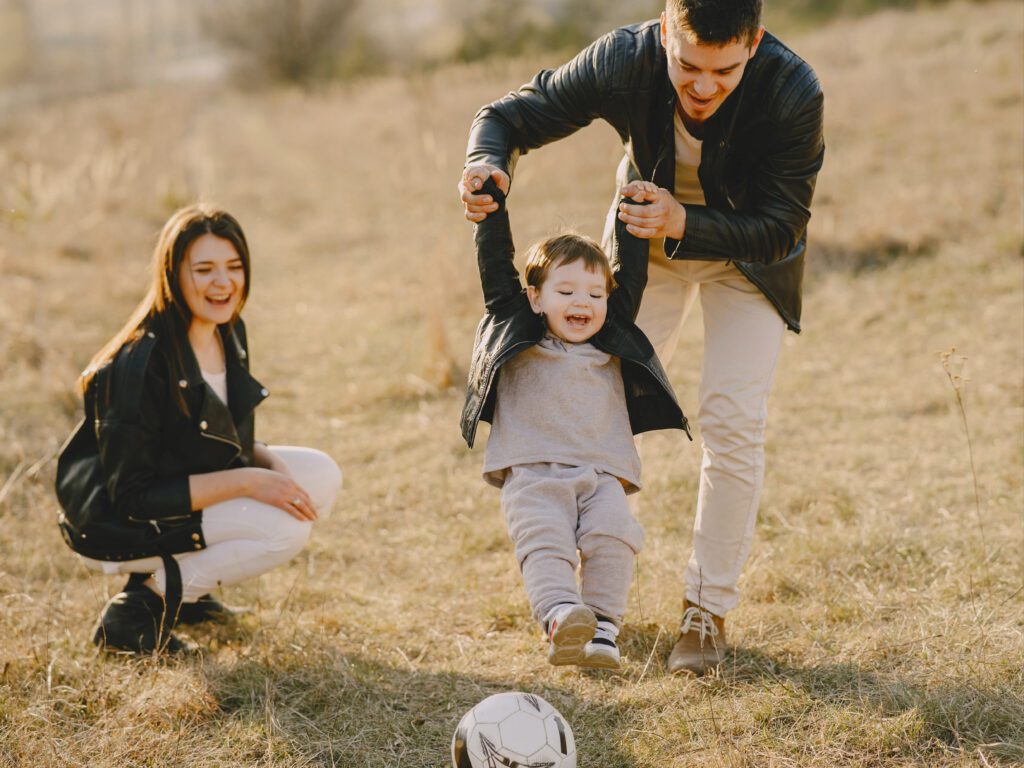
467, 20, 824, 332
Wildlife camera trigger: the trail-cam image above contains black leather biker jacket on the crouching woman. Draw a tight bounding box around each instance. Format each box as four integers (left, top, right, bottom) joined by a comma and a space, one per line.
56, 319, 267, 560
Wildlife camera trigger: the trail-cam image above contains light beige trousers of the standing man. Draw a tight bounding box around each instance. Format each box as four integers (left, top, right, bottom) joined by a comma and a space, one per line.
637, 241, 785, 615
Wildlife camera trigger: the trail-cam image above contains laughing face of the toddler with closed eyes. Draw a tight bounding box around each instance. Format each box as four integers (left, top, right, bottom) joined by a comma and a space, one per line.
526, 259, 608, 344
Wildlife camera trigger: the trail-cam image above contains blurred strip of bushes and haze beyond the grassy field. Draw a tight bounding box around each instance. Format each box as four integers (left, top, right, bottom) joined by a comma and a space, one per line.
0, 0, 966, 101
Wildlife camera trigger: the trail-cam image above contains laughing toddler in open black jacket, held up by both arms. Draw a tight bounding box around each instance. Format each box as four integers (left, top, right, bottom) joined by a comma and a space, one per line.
463, 181, 688, 669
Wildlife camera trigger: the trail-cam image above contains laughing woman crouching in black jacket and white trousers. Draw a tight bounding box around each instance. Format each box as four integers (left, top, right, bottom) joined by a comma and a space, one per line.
56, 205, 341, 653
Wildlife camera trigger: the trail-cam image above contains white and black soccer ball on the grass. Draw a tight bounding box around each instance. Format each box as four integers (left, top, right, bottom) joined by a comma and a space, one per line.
452, 693, 575, 768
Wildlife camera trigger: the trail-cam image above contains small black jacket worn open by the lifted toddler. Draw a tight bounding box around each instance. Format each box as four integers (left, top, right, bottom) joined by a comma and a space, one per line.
462, 179, 689, 447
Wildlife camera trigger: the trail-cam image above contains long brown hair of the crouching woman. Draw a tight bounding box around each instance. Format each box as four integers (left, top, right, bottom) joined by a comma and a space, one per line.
79, 203, 251, 415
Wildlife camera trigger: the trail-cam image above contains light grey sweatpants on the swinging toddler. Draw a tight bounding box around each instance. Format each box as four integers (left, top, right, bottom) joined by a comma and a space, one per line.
502, 463, 643, 625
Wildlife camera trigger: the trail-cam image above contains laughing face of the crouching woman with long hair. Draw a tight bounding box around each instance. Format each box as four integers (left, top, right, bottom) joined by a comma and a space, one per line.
178, 234, 246, 326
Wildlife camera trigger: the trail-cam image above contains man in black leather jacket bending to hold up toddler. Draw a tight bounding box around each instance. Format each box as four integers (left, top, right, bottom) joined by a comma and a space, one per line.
459, 0, 824, 674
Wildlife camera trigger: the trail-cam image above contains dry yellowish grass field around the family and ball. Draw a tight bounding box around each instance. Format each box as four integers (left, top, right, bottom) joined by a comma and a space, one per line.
0, 1, 1024, 768
